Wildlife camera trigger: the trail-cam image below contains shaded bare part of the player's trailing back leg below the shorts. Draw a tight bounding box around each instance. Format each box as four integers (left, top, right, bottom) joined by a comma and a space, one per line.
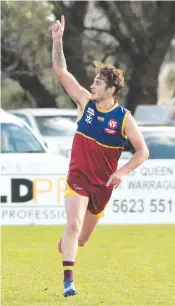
79, 210, 100, 244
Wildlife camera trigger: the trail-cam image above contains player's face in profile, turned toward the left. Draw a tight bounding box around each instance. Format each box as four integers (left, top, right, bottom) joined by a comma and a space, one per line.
90, 75, 109, 102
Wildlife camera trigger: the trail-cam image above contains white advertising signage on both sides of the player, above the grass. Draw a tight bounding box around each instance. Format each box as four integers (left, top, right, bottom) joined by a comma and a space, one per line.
0, 160, 175, 225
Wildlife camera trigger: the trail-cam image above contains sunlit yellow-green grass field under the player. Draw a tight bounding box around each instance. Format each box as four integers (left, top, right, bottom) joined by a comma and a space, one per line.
1, 225, 175, 306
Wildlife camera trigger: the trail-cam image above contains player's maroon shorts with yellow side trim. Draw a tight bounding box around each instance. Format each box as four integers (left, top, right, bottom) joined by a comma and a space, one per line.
65, 175, 113, 217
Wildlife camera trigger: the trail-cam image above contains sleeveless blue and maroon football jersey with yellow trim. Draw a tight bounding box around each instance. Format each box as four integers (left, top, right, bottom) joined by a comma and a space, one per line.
69, 99, 129, 186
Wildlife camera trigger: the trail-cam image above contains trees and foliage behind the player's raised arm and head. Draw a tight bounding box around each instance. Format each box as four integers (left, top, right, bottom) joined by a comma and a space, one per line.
1, 1, 175, 111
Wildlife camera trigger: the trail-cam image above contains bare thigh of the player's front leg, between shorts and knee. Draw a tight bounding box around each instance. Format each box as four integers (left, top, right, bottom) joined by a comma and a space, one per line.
64, 195, 89, 222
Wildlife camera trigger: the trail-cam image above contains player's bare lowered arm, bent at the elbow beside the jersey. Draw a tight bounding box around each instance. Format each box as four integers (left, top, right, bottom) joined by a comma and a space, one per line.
106, 113, 149, 187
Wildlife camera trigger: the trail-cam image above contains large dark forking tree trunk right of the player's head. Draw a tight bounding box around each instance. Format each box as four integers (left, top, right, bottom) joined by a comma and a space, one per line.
98, 1, 175, 113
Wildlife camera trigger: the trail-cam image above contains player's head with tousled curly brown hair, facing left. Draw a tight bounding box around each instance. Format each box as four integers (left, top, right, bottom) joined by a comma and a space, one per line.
91, 62, 124, 101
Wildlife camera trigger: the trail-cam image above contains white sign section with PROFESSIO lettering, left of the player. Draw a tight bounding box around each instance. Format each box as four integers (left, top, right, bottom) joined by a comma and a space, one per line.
1, 174, 66, 225
